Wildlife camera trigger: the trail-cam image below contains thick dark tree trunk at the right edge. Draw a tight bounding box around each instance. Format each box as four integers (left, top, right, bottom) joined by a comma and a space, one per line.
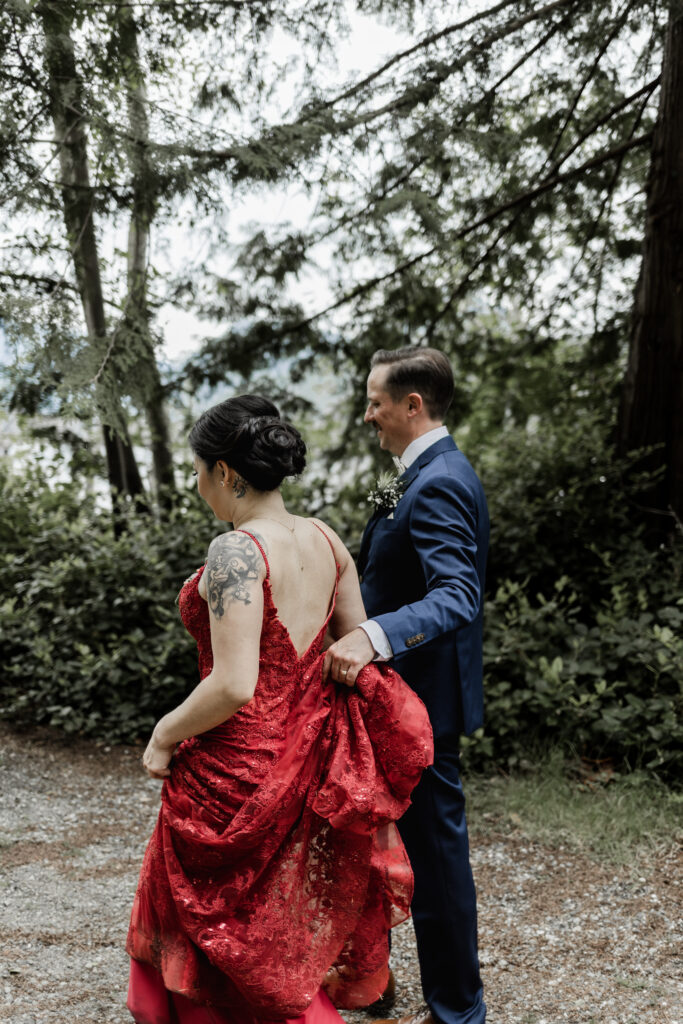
618, 4, 683, 534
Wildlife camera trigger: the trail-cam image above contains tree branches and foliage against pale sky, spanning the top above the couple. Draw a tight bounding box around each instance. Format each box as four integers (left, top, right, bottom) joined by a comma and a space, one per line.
0, 0, 683, 529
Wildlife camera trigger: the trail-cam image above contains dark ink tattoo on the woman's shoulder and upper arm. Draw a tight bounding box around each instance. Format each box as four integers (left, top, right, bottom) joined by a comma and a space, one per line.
207, 530, 265, 618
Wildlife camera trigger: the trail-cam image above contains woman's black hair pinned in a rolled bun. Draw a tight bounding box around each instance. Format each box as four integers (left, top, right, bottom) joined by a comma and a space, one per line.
189, 394, 306, 490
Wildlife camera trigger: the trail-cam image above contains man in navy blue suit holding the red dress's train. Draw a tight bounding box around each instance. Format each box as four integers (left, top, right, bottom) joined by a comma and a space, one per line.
325, 348, 488, 1024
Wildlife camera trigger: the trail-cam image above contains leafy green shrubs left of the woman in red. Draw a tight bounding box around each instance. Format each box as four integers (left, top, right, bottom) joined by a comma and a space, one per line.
0, 471, 220, 740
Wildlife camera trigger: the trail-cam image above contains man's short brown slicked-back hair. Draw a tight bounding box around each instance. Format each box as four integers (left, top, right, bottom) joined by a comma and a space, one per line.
370, 347, 455, 420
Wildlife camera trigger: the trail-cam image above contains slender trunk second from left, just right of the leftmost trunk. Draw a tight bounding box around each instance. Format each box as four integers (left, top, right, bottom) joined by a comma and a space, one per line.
118, 7, 175, 506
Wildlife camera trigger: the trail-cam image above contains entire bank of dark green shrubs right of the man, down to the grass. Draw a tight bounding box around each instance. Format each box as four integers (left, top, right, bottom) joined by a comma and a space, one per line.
469, 408, 683, 777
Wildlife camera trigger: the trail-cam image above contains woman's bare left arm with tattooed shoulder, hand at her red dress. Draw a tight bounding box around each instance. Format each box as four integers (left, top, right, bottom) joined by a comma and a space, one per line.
142, 531, 265, 778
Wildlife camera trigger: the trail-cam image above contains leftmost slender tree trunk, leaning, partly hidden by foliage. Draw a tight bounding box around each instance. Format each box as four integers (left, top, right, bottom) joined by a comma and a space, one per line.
37, 0, 143, 506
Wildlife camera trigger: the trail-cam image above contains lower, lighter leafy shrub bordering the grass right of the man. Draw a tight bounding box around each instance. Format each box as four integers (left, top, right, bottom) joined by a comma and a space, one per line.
467, 578, 683, 778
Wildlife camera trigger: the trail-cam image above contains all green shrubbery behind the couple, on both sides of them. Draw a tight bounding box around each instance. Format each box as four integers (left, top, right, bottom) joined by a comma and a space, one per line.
0, 401, 683, 779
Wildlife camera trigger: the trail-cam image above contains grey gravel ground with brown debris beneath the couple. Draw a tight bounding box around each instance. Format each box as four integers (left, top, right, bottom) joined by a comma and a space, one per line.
0, 725, 683, 1024
